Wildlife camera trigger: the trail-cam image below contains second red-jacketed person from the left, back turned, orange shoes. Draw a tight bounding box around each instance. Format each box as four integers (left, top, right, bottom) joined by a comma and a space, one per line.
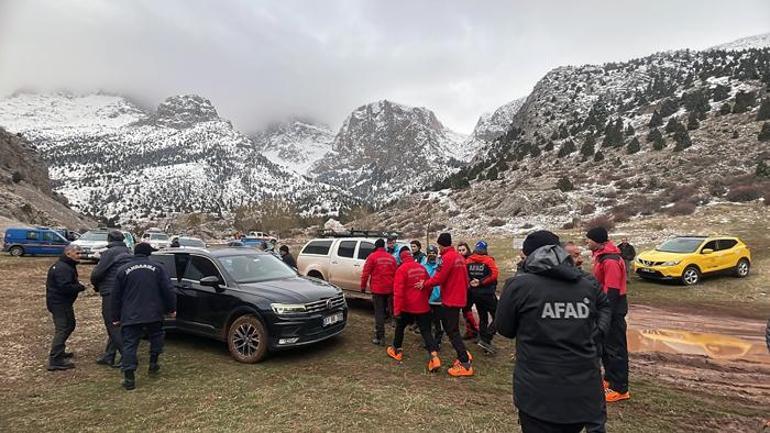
387, 247, 441, 372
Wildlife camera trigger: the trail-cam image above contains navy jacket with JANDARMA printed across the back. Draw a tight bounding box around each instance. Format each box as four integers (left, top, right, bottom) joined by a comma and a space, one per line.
110, 255, 176, 325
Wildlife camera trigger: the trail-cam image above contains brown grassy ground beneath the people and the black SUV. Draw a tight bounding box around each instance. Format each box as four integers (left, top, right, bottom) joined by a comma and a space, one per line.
0, 257, 768, 432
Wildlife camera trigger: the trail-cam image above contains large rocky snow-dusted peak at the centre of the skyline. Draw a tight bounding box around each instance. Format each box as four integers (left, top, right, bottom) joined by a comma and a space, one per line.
313, 100, 466, 204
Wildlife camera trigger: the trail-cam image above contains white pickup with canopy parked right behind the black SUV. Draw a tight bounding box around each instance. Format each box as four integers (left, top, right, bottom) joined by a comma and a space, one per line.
297, 231, 409, 297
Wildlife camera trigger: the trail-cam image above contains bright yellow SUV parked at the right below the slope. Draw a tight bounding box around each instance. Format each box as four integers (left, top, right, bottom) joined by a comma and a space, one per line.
634, 236, 751, 286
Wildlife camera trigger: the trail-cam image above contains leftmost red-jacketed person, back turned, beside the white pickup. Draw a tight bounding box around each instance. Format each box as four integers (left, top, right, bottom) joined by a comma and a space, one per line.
361, 239, 397, 346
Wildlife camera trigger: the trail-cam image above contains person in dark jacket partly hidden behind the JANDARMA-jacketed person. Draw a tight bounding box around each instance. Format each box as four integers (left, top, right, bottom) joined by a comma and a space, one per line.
91, 230, 131, 367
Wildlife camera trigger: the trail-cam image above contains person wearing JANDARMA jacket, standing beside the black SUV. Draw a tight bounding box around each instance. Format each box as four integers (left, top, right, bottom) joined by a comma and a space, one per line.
112, 242, 176, 390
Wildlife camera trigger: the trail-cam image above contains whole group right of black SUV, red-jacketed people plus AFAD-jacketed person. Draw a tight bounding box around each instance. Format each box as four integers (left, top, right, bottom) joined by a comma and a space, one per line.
360, 227, 633, 432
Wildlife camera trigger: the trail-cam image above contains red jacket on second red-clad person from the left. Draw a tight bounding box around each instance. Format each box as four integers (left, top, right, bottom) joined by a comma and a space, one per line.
393, 251, 431, 316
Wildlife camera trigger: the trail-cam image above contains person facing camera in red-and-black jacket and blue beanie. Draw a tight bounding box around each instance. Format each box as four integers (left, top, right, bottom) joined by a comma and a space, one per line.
466, 241, 500, 354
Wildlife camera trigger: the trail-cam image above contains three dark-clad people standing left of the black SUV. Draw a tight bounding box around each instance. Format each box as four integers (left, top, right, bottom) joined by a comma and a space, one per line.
46, 230, 176, 390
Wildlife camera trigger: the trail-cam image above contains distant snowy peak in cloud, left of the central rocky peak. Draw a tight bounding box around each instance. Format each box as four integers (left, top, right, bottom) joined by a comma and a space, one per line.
251, 119, 334, 175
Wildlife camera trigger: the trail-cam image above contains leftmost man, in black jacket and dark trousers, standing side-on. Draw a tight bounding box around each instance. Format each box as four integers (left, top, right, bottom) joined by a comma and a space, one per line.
45, 245, 86, 371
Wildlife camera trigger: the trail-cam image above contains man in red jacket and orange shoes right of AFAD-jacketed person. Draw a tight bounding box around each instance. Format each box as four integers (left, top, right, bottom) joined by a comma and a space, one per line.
586, 227, 631, 402
